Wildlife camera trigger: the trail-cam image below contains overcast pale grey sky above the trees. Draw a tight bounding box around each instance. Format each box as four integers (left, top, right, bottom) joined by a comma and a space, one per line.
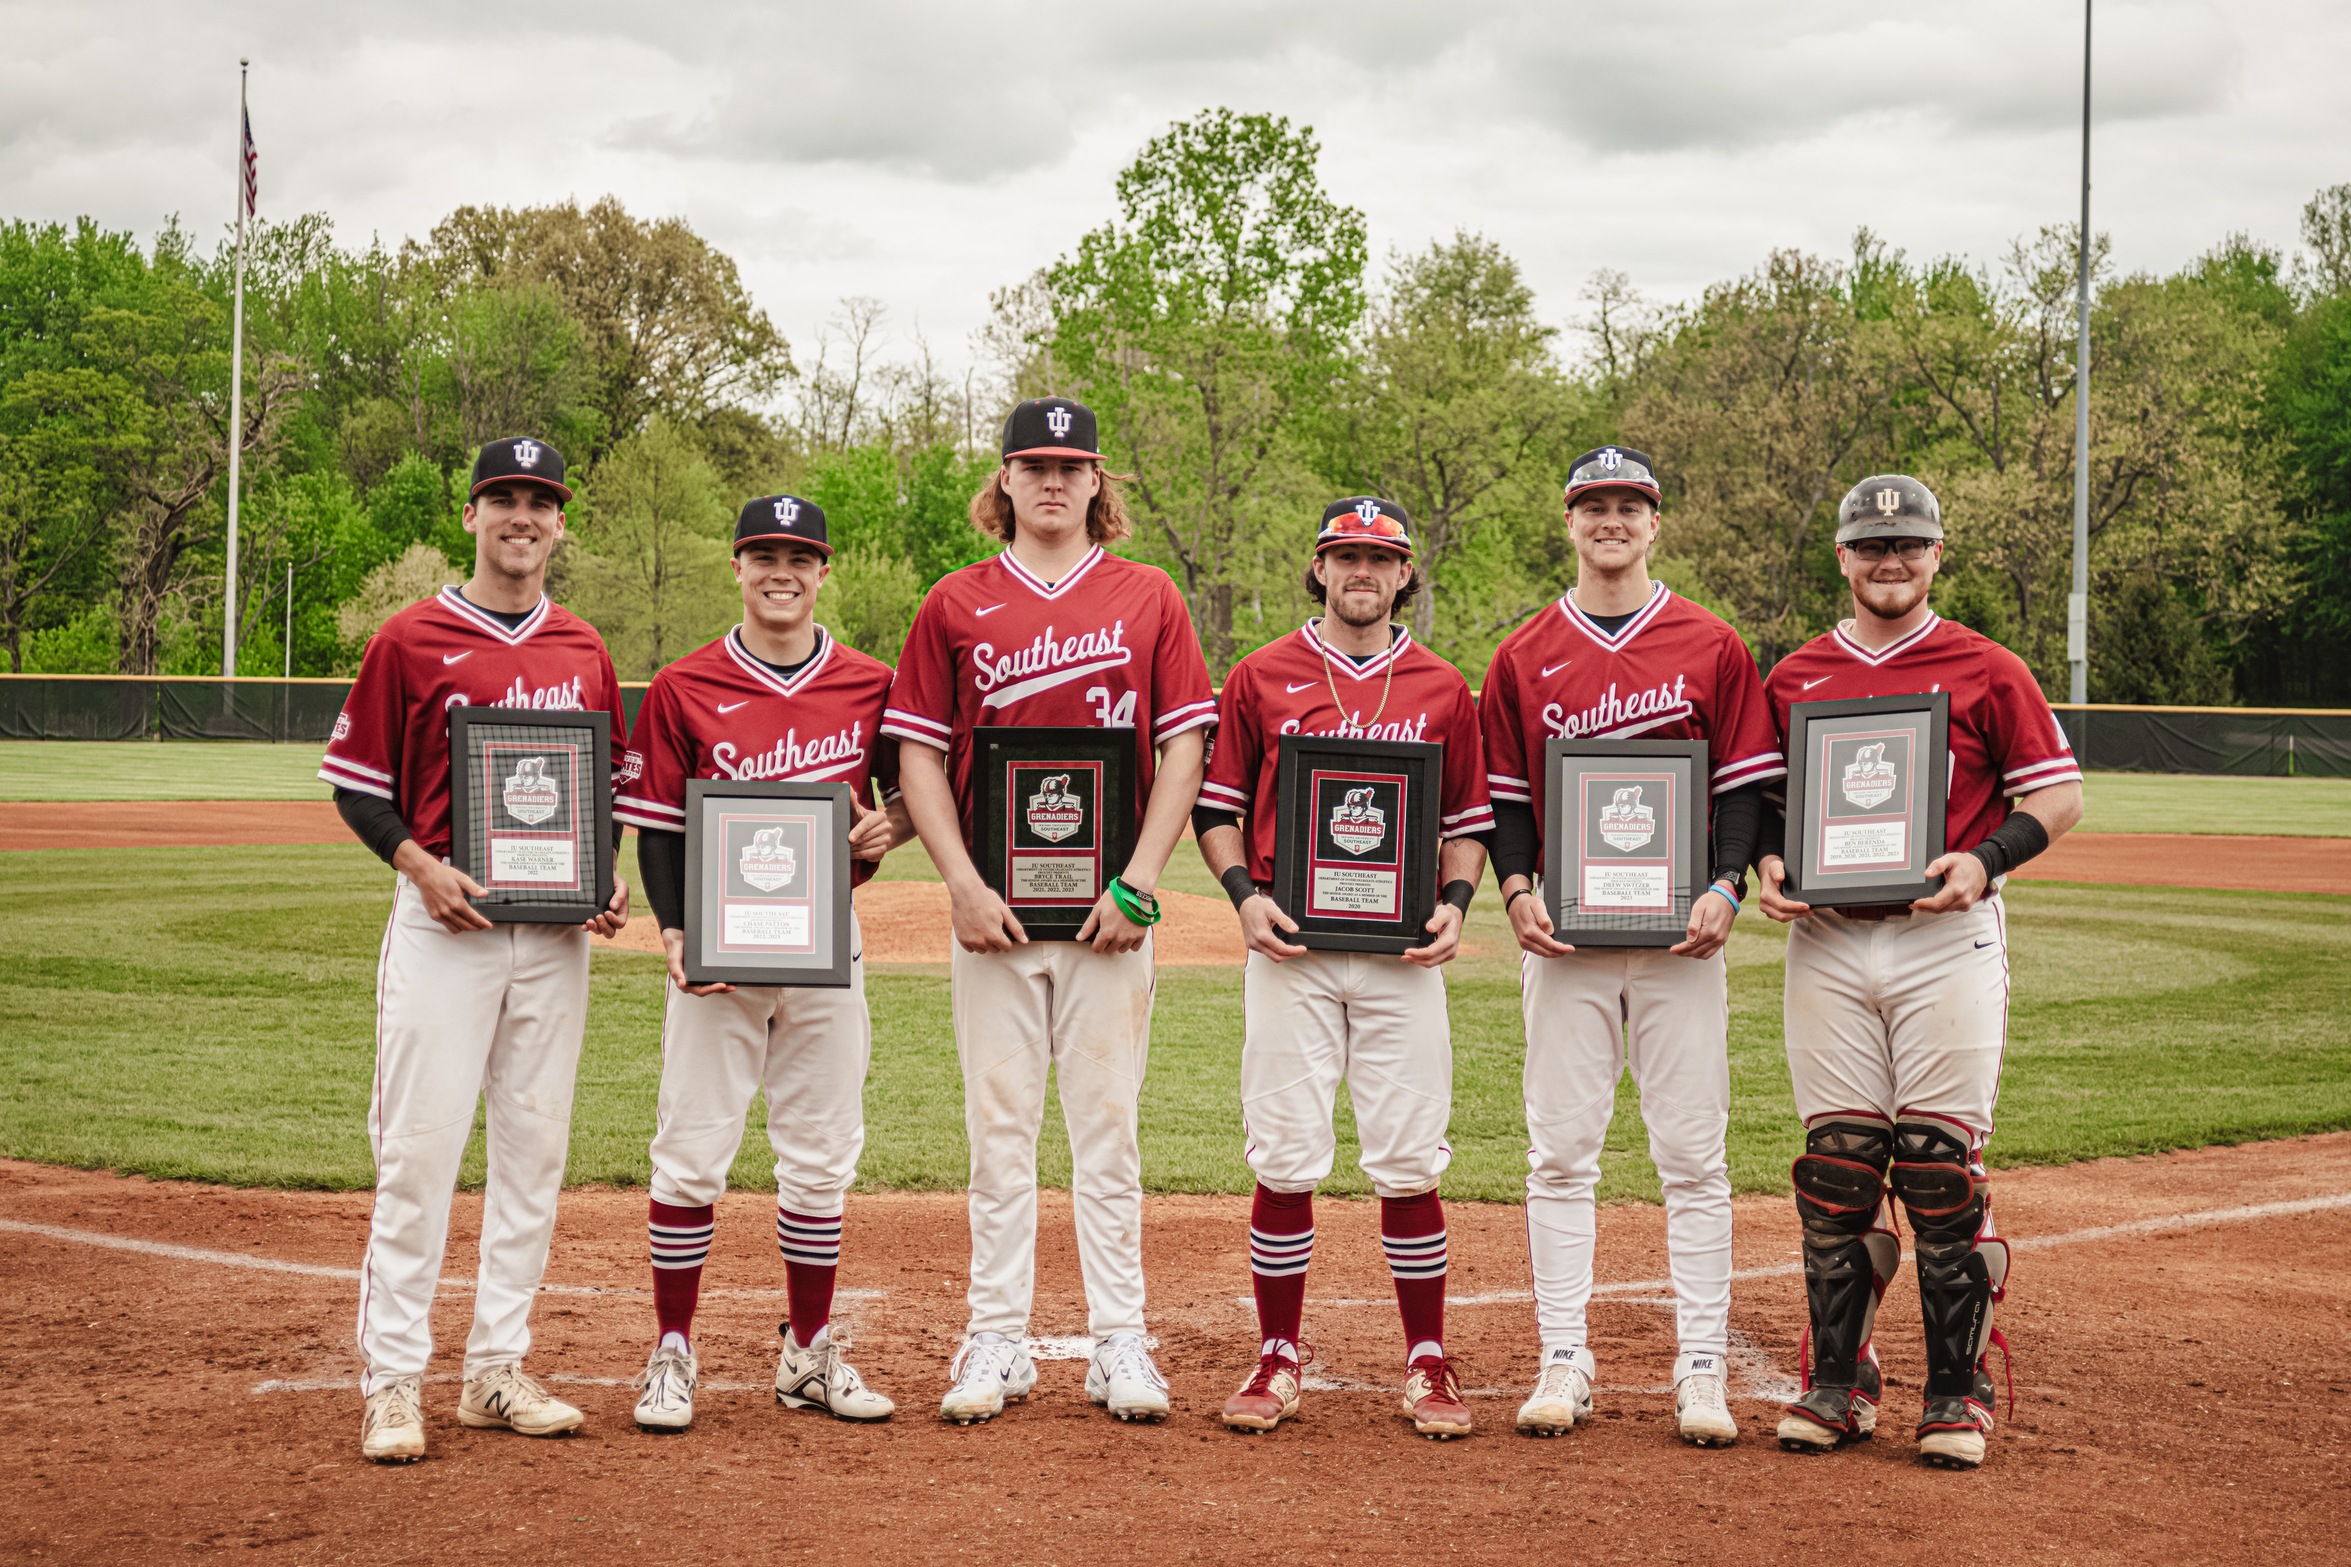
0, 0, 2351, 375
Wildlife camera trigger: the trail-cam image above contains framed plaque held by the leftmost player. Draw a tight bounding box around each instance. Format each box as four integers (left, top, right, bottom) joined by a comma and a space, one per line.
449, 707, 611, 926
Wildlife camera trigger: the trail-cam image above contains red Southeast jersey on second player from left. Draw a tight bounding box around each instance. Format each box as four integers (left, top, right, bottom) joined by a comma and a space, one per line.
611, 627, 898, 886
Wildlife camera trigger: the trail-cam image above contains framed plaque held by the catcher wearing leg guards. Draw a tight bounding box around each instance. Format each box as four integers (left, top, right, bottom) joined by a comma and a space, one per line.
1784, 691, 1951, 909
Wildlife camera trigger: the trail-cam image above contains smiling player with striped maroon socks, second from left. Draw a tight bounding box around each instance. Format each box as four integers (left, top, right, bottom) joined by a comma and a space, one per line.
614, 496, 912, 1431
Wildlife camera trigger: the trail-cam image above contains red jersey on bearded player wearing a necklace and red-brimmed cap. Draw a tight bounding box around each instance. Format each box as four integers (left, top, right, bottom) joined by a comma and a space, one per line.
1199, 620, 1493, 886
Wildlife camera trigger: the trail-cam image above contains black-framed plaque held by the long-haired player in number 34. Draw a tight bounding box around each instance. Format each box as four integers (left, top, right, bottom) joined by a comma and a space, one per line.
971, 726, 1136, 942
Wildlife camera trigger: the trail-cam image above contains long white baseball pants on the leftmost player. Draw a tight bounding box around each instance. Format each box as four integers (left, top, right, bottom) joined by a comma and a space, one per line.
360, 876, 588, 1393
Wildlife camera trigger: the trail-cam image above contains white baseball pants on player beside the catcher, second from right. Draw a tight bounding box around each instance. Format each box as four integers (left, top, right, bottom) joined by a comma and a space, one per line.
1519, 947, 1730, 1356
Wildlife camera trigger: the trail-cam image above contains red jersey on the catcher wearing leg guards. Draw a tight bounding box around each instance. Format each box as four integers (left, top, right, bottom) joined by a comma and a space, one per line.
1763, 613, 2081, 853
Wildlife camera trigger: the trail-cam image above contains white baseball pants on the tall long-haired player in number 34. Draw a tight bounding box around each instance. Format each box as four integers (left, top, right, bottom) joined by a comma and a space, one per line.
952, 937, 1157, 1341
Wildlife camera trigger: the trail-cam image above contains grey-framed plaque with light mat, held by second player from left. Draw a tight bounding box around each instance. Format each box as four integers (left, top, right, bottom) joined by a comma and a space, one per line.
684, 778, 856, 989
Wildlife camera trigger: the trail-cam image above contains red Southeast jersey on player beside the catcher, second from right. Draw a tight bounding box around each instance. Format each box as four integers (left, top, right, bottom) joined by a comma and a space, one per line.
1476, 583, 1787, 829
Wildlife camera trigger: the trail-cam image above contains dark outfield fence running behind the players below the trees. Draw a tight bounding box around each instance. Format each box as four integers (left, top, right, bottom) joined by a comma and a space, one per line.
0, 674, 2351, 778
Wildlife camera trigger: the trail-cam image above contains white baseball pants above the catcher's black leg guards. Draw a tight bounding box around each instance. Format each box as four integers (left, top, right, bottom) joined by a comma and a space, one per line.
1784, 895, 2008, 1149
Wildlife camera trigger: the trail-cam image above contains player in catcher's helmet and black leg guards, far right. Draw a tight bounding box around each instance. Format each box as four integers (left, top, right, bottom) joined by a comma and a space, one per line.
1756, 475, 2081, 1468
